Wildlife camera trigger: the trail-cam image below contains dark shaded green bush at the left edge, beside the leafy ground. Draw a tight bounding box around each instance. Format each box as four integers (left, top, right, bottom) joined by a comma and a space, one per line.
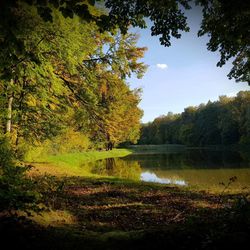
0, 137, 40, 215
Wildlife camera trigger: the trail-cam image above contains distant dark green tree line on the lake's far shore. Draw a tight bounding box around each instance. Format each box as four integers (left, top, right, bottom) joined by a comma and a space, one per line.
138, 91, 250, 146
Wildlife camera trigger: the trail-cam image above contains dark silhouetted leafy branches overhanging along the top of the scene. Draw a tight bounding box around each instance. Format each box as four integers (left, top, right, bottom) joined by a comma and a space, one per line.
0, 0, 250, 83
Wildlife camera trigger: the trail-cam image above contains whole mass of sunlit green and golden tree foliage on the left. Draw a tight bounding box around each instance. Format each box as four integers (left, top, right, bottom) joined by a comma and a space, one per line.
0, 4, 146, 150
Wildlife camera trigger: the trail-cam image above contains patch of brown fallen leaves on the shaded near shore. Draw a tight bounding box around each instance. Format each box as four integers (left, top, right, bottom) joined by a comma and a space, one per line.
38, 178, 230, 232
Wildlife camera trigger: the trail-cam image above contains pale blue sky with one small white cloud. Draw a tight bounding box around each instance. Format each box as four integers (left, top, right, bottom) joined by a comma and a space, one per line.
128, 5, 250, 123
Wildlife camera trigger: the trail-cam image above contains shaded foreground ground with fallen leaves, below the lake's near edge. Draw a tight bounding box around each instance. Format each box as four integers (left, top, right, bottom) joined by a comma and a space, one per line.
0, 176, 250, 249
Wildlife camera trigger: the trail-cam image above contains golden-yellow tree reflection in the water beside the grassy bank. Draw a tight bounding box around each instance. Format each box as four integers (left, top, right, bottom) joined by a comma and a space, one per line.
91, 158, 142, 180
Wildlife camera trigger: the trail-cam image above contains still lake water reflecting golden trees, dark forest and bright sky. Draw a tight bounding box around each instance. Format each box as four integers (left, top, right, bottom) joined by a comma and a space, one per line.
91, 149, 250, 190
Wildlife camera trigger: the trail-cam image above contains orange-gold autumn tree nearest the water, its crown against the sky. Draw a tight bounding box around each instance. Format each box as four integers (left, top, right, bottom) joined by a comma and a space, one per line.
75, 31, 146, 149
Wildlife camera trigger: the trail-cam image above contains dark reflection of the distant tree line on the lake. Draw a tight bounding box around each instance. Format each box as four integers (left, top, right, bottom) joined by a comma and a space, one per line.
124, 149, 250, 169
